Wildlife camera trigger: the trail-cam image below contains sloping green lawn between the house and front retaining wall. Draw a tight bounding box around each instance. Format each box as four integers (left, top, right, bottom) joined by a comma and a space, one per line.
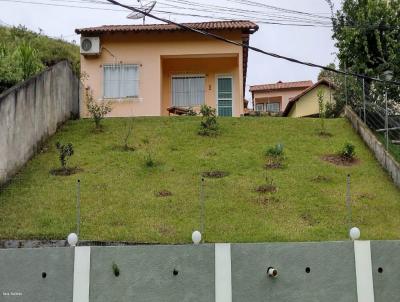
0, 117, 400, 243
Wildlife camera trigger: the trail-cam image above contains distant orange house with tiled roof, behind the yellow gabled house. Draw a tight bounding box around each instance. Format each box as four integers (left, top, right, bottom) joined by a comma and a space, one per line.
250, 81, 313, 113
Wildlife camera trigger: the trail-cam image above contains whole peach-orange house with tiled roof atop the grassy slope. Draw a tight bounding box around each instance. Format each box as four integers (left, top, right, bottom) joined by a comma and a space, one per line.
76, 21, 258, 117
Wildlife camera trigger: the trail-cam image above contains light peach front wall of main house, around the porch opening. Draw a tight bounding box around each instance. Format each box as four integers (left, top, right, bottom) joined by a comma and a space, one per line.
81, 31, 243, 117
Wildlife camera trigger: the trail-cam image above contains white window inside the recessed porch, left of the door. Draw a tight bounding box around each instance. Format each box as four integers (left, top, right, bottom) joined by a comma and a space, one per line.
172, 76, 205, 107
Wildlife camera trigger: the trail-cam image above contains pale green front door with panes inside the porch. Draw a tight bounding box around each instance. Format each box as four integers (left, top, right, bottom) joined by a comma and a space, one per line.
217, 76, 233, 116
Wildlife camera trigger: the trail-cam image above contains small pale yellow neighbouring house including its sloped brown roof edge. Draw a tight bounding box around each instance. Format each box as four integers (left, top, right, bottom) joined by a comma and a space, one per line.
283, 79, 335, 117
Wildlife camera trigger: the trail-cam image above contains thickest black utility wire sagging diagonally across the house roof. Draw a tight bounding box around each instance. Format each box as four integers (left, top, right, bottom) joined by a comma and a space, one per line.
103, 0, 400, 86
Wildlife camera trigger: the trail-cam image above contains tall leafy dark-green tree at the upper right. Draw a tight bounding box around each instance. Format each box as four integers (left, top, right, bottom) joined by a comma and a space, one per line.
333, 0, 400, 101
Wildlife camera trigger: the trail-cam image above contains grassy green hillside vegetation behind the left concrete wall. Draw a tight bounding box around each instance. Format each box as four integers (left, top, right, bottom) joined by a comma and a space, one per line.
0, 26, 80, 93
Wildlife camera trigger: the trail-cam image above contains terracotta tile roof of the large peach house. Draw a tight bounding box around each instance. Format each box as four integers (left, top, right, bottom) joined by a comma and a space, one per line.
75, 20, 258, 34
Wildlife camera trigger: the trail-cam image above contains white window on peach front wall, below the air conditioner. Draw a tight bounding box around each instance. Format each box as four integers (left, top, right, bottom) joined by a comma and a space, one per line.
104, 64, 139, 98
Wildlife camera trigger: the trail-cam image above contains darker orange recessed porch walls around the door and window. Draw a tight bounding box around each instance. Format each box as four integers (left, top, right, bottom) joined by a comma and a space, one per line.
161, 56, 244, 116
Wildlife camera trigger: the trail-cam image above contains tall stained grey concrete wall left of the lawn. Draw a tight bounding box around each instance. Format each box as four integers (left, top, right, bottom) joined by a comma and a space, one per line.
0, 61, 79, 184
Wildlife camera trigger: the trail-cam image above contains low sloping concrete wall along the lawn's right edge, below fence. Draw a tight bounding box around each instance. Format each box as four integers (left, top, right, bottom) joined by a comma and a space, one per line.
345, 106, 400, 188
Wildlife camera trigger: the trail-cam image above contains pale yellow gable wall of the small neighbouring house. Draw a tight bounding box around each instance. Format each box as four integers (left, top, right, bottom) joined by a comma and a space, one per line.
288, 85, 334, 117
